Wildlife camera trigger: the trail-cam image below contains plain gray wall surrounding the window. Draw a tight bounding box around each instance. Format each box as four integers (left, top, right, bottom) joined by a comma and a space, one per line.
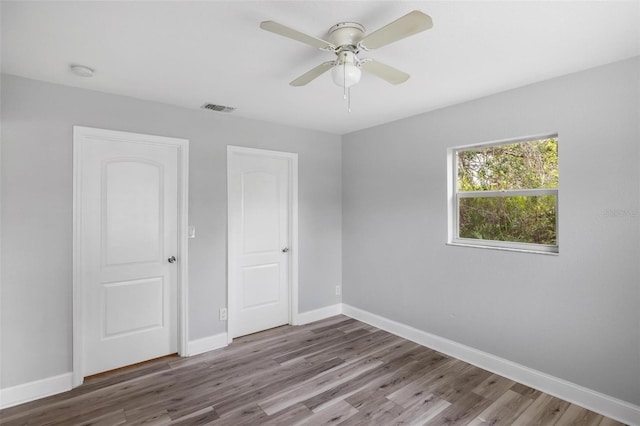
342, 58, 640, 405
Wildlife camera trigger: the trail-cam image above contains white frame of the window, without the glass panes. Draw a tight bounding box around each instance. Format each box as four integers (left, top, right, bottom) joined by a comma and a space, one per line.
447, 133, 560, 254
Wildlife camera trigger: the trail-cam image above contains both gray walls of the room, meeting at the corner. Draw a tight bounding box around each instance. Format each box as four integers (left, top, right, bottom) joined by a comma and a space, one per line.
0, 58, 640, 410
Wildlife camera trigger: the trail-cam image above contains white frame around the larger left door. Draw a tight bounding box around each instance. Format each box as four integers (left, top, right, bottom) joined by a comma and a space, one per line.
72, 126, 189, 387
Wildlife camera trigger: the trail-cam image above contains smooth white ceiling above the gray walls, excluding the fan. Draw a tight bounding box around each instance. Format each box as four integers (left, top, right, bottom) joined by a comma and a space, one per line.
1, 0, 640, 134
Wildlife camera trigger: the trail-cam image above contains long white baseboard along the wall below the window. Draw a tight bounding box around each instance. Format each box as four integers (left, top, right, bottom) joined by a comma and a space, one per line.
342, 304, 640, 425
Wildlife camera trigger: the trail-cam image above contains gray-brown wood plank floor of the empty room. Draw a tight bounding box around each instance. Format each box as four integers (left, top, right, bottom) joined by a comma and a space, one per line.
0, 316, 621, 426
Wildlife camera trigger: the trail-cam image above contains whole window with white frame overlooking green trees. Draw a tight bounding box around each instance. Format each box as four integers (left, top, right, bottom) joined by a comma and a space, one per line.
449, 135, 558, 253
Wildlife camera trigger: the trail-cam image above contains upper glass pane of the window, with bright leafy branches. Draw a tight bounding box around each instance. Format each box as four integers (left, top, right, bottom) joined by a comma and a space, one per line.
457, 138, 558, 192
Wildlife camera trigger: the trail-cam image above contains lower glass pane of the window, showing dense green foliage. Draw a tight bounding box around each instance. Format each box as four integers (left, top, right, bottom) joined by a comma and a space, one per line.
459, 195, 557, 245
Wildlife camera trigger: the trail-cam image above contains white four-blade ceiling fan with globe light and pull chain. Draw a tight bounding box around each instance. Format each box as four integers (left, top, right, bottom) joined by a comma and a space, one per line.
260, 10, 433, 91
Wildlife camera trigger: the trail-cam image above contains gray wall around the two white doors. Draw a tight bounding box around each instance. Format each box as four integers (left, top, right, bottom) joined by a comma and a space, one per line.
0, 75, 342, 388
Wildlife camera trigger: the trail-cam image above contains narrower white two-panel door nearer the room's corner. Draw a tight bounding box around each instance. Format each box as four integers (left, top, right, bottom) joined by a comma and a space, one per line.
228, 147, 292, 338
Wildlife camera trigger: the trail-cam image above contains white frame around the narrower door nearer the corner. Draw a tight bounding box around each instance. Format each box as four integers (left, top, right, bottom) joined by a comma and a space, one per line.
227, 145, 298, 343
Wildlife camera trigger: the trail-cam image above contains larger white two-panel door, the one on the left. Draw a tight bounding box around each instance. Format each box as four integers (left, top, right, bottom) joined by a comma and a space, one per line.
74, 128, 185, 376
